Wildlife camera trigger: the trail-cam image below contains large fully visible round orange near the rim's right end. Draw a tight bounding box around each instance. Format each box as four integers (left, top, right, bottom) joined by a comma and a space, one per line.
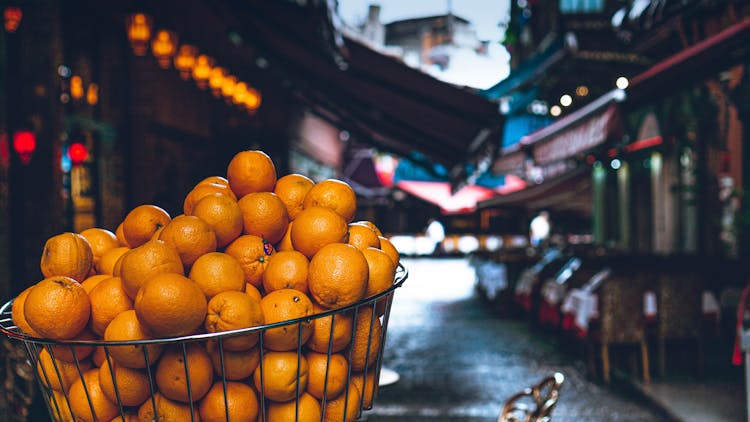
307, 243, 369, 309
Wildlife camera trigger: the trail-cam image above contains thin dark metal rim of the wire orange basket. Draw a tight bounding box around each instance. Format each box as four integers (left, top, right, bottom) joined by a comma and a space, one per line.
0, 263, 409, 346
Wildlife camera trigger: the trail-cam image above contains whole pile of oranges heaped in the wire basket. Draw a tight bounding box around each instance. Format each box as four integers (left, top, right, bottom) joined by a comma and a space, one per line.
12, 151, 399, 421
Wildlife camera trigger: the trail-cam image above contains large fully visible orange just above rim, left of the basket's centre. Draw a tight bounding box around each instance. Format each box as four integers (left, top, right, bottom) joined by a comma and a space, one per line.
134, 273, 207, 338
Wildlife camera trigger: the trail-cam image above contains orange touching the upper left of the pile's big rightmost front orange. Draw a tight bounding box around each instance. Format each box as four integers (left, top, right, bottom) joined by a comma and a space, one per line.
290, 207, 349, 258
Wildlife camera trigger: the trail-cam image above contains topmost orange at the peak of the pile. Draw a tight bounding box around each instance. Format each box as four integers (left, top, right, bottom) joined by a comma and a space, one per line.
227, 150, 276, 198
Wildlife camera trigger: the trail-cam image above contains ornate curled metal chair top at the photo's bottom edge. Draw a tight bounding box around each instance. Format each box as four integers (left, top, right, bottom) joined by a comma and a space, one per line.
497, 372, 565, 422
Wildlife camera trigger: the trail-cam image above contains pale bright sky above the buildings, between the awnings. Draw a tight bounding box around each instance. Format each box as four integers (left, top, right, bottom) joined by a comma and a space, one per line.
338, 0, 510, 89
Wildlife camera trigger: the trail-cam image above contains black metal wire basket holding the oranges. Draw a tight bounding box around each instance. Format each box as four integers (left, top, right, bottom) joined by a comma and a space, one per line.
0, 265, 408, 422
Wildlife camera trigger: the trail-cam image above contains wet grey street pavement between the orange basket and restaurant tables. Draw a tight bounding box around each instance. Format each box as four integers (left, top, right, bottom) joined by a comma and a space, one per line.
363, 259, 668, 422
